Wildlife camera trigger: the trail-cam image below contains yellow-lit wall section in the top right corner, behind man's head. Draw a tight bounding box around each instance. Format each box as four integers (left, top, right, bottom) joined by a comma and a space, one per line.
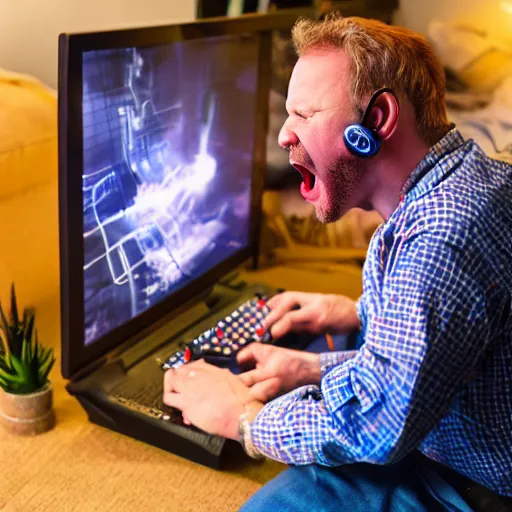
394, 0, 512, 39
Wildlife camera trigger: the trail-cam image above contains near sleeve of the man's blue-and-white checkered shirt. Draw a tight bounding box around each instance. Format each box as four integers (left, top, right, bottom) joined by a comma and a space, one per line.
248, 233, 496, 465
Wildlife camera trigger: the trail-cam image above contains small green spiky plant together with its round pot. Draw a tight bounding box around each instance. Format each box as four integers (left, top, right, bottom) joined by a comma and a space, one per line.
0, 284, 55, 435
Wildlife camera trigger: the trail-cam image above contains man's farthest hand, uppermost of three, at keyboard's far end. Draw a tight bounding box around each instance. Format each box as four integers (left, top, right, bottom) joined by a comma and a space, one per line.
263, 292, 361, 339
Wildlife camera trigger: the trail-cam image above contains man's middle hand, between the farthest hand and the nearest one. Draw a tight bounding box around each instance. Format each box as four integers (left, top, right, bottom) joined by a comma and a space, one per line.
237, 343, 321, 402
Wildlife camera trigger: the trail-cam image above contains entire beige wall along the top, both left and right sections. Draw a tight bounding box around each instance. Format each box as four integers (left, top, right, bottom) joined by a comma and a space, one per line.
0, 0, 512, 87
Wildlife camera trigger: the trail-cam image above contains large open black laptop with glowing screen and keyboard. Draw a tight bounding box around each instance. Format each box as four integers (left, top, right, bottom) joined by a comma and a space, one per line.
59, 13, 312, 468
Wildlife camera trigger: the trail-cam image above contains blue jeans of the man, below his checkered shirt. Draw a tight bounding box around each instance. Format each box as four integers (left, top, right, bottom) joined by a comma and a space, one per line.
240, 456, 472, 512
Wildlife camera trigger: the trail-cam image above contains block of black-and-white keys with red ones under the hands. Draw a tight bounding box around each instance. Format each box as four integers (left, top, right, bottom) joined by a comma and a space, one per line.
161, 296, 271, 371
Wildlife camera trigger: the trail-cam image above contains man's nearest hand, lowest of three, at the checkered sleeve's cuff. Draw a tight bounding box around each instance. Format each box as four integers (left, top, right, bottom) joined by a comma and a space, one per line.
163, 360, 255, 441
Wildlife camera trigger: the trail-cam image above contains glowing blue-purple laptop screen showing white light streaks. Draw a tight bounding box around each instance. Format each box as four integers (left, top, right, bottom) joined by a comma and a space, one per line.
82, 34, 258, 345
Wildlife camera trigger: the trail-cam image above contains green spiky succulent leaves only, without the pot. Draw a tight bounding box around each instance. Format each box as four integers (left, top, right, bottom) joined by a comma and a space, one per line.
0, 284, 55, 394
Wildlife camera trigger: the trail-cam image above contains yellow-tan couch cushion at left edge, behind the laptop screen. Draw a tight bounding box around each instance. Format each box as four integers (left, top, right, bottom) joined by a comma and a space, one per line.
0, 69, 57, 198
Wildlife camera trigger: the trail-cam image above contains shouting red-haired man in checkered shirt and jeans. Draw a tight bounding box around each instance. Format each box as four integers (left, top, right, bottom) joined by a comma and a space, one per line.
164, 16, 512, 511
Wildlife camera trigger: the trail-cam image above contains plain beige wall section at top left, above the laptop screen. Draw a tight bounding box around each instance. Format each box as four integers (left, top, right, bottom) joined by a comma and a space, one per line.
0, 0, 196, 87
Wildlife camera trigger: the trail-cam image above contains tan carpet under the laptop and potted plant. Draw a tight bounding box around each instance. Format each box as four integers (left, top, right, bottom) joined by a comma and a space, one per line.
0, 266, 360, 512
